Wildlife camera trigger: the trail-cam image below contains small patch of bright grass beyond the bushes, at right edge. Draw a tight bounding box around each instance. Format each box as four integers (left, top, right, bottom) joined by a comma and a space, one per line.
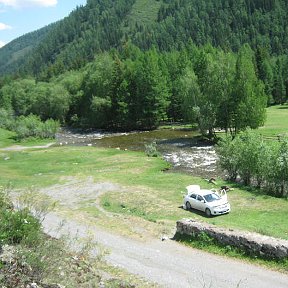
259, 105, 288, 137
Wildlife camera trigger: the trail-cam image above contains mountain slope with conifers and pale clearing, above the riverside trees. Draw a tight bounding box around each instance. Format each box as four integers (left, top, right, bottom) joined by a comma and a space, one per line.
0, 0, 288, 79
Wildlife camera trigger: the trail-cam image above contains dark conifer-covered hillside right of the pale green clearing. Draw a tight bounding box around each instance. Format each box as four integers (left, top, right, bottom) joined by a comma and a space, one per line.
143, 0, 288, 55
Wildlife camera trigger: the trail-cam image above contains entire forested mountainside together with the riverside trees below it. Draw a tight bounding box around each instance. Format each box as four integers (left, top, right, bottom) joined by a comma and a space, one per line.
0, 0, 288, 137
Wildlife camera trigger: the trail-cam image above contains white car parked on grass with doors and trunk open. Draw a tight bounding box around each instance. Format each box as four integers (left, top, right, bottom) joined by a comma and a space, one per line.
183, 185, 230, 217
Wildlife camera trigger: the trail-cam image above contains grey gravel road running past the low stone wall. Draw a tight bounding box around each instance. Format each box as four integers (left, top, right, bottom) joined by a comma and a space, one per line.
43, 213, 288, 288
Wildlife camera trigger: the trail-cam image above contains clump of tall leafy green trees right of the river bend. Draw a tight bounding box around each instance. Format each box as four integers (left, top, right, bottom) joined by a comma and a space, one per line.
182, 45, 267, 138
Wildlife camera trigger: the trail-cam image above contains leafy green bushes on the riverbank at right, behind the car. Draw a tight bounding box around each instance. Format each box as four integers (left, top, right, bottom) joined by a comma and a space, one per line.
216, 130, 288, 197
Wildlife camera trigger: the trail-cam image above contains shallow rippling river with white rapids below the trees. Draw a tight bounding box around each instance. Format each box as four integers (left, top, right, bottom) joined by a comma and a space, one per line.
57, 129, 221, 178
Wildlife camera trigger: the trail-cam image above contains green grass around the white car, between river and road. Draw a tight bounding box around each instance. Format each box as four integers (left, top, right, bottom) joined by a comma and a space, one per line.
0, 147, 288, 239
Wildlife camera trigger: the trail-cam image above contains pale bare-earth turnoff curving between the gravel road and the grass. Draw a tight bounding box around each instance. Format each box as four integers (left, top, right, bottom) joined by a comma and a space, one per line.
40, 177, 171, 240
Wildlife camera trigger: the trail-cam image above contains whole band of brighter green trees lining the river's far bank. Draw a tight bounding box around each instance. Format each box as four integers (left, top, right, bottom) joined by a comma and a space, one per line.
0, 43, 270, 138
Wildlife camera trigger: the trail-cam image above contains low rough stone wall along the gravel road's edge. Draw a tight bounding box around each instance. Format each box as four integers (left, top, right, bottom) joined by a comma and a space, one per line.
177, 219, 288, 259
